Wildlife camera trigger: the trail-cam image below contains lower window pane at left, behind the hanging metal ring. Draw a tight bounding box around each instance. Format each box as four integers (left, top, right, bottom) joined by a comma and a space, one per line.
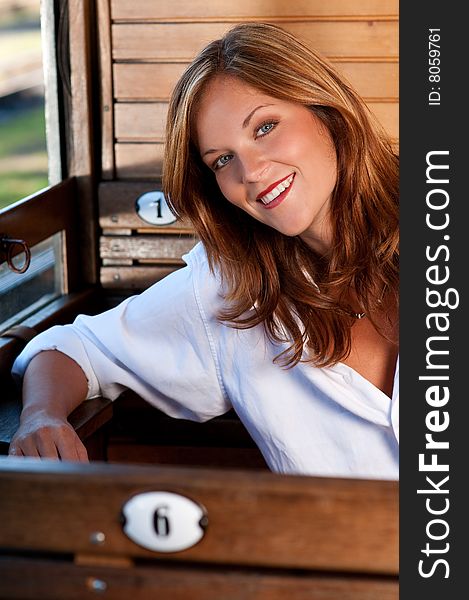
0, 233, 65, 331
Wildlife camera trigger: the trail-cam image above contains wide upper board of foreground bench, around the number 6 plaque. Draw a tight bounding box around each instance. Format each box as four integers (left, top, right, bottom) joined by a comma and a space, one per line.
0, 457, 399, 575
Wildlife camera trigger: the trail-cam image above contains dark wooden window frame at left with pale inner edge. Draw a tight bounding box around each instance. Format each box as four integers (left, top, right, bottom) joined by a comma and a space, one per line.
0, 0, 102, 386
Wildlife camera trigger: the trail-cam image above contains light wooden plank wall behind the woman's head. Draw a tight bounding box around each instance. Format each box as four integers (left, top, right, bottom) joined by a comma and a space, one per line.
97, 0, 399, 287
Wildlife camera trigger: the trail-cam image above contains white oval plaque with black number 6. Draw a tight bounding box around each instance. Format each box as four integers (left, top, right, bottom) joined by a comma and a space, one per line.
122, 492, 207, 552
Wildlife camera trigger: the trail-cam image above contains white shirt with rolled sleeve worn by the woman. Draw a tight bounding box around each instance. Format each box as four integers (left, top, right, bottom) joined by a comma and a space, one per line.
13, 244, 399, 479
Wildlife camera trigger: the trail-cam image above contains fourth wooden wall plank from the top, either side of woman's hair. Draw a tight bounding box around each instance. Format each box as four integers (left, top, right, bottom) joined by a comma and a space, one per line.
115, 102, 399, 143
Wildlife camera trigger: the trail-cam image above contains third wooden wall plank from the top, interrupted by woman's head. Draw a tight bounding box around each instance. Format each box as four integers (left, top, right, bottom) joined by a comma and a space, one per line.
114, 62, 399, 102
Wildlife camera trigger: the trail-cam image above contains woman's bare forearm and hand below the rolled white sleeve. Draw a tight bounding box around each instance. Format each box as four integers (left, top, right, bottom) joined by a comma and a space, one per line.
9, 350, 88, 461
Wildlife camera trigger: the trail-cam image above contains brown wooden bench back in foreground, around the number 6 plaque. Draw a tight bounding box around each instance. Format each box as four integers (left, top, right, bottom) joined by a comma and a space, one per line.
0, 458, 398, 600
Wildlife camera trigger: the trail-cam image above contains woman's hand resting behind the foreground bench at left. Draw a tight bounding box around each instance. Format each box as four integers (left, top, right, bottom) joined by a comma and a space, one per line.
8, 411, 88, 462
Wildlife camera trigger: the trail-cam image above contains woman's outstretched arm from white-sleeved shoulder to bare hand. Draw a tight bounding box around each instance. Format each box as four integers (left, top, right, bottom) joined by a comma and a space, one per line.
10, 248, 231, 459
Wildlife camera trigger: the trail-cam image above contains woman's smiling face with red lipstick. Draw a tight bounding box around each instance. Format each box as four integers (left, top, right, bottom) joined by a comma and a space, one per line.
195, 76, 337, 253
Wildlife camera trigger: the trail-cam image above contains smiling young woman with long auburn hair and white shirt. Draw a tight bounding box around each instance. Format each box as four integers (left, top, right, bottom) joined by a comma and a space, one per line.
10, 24, 399, 479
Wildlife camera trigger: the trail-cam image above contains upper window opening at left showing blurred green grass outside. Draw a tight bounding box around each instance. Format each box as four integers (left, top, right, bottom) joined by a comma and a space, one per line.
0, 0, 48, 208
